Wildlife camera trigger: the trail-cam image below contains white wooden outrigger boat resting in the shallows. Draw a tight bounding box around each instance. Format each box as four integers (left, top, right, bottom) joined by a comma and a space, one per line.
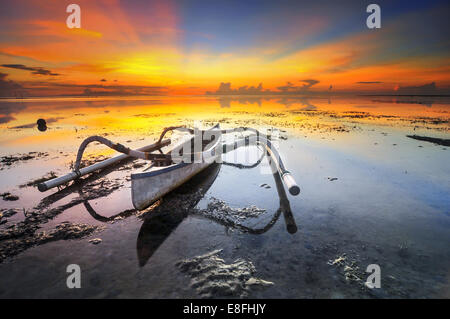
38, 124, 300, 210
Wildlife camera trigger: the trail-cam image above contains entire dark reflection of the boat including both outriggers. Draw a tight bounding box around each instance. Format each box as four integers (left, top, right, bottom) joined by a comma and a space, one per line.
38, 149, 297, 267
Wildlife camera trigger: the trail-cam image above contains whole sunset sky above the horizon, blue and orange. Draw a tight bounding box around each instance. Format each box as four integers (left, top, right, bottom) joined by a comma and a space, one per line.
0, 0, 450, 96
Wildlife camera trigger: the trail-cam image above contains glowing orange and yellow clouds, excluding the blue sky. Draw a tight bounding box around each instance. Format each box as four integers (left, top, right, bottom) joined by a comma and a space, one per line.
0, 0, 450, 94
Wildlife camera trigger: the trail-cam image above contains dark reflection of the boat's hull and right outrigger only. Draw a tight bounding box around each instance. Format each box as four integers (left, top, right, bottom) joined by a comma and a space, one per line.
136, 158, 297, 267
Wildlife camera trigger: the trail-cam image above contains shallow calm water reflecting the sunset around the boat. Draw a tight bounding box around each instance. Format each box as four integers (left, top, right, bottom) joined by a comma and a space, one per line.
0, 96, 450, 298
